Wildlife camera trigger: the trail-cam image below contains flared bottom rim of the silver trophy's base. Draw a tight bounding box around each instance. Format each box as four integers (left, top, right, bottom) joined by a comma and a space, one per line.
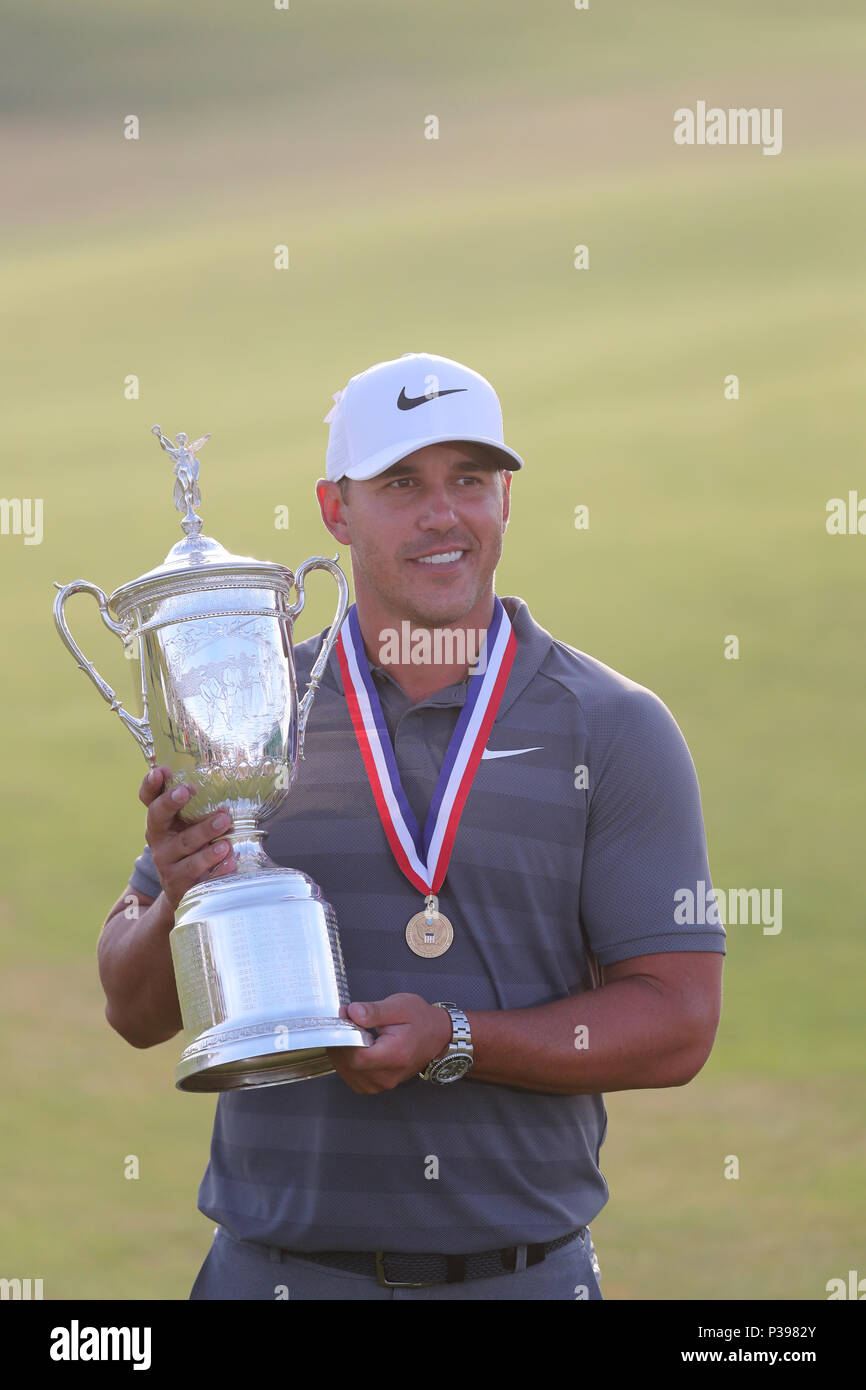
174, 1019, 370, 1093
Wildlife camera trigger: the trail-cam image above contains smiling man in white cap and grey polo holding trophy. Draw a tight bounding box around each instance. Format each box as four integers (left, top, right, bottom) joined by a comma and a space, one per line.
100, 353, 724, 1301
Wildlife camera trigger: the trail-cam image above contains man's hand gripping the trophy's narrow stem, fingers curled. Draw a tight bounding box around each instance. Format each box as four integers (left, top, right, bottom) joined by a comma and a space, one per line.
139, 767, 236, 912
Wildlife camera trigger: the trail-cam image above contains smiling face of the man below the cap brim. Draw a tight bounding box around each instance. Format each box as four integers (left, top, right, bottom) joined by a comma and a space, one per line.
316, 443, 512, 627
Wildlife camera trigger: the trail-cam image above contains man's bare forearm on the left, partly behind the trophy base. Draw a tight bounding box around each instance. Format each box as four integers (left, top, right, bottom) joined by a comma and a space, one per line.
97, 892, 183, 1047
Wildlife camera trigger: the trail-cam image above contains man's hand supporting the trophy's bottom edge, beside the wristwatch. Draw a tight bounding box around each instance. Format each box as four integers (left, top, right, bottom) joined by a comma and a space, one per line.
328, 994, 452, 1095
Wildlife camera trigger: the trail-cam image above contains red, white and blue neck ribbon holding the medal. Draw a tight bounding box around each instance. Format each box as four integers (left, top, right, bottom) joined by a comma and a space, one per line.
336, 595, 517, 897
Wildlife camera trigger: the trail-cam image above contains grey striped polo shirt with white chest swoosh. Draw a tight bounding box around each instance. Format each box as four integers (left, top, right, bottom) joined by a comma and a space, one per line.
132, 598, 724, 1254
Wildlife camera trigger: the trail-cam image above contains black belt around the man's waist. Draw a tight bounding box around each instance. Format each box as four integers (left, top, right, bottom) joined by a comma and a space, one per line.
240, 1226, 587, 1289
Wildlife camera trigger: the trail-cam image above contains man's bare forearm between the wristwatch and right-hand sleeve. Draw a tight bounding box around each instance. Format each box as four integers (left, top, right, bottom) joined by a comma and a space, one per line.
467, 977, 714, 1095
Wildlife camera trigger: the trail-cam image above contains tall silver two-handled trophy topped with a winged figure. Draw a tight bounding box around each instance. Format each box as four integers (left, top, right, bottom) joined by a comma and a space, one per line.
54, 425, 371, 1091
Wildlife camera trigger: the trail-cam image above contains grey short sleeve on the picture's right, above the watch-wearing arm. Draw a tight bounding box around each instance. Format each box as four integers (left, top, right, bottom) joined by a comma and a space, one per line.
580, 685, 726, 965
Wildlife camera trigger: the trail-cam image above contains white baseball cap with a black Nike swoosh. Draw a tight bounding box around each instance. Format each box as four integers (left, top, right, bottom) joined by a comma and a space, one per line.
324, 352, 523, 482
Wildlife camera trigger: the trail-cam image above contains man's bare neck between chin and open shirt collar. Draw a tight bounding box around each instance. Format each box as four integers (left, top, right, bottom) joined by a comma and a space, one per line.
354, 589, 493, 705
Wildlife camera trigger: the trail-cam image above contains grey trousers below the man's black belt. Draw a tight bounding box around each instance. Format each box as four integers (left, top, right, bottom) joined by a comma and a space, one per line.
189, 1226, 602, 1302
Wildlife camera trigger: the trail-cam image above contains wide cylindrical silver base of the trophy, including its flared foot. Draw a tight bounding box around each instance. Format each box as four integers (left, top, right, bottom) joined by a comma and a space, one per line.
168, 866, 373, 1091
